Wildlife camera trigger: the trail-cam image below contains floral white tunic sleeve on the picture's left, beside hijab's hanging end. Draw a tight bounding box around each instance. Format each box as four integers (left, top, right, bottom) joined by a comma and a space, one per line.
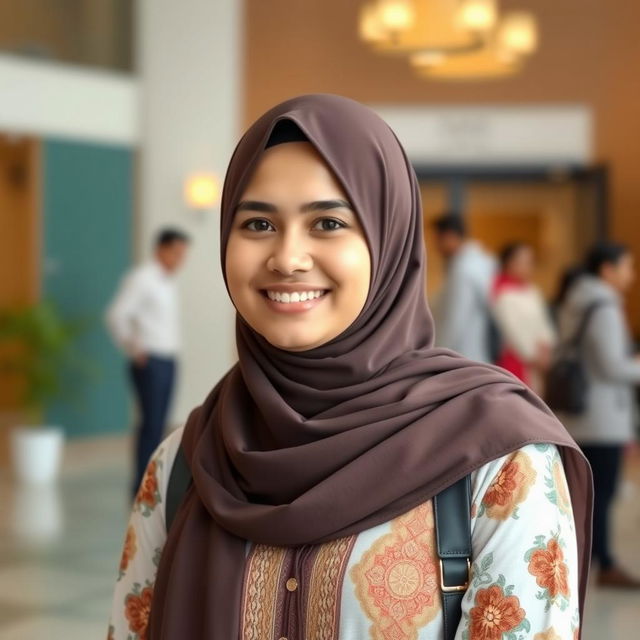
107, 427, 183, 640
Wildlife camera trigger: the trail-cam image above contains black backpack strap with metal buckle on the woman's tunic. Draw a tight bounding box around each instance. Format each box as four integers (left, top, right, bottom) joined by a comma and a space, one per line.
433, 475, 471, 640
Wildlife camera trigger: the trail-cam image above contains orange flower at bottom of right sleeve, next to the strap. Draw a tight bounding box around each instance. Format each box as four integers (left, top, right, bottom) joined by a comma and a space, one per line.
469, 584, 526, 640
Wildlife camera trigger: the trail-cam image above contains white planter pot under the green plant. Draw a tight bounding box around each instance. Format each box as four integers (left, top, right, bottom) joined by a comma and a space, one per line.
11, 426, 64, 484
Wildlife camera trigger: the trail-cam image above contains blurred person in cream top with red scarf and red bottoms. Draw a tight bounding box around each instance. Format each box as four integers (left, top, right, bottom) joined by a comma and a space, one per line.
492, 242, 556, 394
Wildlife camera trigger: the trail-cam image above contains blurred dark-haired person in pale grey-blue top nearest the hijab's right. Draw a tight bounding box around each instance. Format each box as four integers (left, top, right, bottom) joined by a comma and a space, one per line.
433, 213, 496, 362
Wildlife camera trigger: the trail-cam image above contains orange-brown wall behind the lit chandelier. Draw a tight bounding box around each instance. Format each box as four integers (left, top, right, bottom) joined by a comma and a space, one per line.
244, 0, 640, 331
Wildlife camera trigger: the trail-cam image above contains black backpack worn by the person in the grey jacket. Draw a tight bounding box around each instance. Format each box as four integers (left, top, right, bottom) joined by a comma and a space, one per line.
545, 301, 606, 415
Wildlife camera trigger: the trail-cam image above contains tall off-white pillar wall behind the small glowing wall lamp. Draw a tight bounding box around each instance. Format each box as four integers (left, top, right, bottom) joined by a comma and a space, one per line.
137, 0, 243, 422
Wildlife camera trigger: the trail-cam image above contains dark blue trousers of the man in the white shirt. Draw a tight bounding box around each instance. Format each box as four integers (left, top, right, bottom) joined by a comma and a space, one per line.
129, 356, 176, 495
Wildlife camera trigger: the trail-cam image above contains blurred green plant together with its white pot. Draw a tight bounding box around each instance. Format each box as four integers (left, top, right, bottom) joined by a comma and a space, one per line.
0, 302, 87, 484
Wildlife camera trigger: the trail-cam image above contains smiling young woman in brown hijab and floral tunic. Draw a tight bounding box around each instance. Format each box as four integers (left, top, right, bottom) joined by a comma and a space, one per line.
110, 95, 592, 640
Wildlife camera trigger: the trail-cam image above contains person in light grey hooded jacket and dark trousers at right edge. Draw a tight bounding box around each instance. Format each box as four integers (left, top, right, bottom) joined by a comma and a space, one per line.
558, 242, 640, 589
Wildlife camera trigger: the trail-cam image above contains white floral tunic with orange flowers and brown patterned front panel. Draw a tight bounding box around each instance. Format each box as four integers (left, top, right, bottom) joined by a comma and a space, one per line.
108, 429, 580, 640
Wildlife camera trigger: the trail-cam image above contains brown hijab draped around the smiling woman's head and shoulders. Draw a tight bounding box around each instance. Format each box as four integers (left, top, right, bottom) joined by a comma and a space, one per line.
149, 94, 593, 640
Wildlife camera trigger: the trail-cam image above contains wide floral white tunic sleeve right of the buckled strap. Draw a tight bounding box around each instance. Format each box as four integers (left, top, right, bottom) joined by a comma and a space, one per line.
455, 444, 580, 640
